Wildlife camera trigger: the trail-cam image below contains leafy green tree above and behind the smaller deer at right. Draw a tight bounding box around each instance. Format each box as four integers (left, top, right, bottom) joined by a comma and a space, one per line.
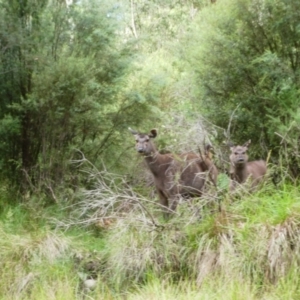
186, 0, 300, 170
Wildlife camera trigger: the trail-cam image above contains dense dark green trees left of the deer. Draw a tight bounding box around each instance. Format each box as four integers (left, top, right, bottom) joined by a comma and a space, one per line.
0, 0, 159, 198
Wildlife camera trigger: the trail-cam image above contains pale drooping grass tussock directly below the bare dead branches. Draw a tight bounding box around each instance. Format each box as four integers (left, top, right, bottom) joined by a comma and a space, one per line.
101, 210, 188, 289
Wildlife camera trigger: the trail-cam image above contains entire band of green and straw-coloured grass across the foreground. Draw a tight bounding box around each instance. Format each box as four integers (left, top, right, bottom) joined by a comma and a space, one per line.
0, 180, 300, 300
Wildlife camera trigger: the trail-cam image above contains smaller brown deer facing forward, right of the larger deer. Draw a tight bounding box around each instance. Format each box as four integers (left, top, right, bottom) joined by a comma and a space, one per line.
230, 140, 267, 191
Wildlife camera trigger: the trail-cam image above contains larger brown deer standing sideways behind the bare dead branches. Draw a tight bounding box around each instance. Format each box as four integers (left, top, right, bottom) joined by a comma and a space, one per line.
129, 129, 218, 217
